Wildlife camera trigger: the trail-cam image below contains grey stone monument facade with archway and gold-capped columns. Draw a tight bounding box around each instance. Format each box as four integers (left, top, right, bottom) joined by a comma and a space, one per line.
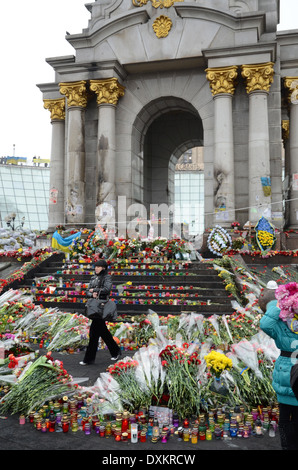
38, 0, 298, 235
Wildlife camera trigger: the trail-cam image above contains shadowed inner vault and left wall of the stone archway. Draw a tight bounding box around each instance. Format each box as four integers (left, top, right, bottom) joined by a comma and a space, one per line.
132, 97, 204, 237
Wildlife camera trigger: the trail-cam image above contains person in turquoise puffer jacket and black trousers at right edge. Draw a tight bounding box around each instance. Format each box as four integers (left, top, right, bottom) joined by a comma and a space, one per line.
260, 296, 298, 450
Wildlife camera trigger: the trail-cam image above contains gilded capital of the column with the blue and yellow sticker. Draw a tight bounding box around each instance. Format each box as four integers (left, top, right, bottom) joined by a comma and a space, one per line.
241, 62, 274, 93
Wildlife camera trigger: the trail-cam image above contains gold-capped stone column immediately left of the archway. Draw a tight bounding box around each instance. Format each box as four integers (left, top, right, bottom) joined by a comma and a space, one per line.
90, 77, 124, 225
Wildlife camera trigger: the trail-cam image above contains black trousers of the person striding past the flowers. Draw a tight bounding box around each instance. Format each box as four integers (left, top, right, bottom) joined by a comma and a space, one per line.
84, 318, 120, 363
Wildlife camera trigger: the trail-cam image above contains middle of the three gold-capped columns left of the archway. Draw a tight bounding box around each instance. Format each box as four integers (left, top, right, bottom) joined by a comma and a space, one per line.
59, 80, 87, 224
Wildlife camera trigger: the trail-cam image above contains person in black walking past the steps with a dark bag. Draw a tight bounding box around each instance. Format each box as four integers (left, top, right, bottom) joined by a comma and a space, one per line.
80, 259, 121, 366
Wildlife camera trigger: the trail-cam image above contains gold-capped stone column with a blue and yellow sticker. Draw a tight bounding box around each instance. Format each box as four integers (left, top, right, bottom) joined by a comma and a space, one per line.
241, 62, 274, 223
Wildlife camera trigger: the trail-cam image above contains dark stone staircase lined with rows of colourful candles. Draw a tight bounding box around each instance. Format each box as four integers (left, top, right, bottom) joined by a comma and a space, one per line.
18, 253, 233, 317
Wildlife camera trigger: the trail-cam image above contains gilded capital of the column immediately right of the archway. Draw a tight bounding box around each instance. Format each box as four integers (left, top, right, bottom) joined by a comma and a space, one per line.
205, 65, 238, 96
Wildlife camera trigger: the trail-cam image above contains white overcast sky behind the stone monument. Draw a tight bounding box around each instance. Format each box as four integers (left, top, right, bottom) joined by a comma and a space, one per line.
0, 0, 298, 159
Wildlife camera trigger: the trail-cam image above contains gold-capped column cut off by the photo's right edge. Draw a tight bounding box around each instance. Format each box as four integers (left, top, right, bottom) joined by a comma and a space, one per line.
284, 77, 298, 229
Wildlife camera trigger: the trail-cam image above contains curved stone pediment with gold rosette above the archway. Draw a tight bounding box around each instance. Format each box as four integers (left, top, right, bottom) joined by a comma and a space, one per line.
67, 0, 266, 69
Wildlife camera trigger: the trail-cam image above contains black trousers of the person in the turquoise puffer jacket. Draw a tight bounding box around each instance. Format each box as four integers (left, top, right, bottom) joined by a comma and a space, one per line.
278, 403, 298, 450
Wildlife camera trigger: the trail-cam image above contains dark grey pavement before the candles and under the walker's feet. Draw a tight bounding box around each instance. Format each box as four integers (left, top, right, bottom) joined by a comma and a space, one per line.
0, 349, 281, 452
